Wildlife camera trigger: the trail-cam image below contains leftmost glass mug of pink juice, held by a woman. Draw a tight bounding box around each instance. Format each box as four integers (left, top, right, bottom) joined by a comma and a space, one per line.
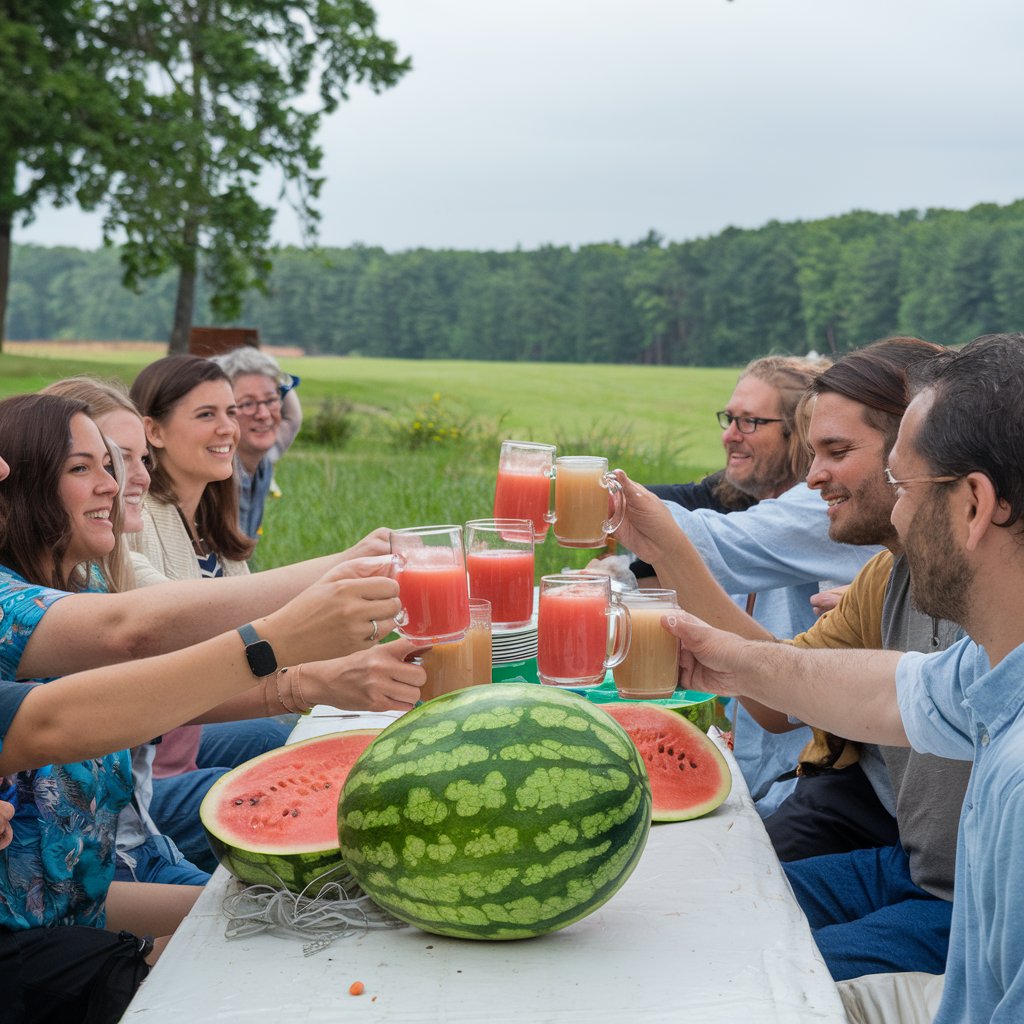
391, 525, 469, 643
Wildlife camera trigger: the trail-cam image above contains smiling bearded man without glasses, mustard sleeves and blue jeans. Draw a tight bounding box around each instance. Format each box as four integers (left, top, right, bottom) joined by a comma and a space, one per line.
620, 339, 970, 980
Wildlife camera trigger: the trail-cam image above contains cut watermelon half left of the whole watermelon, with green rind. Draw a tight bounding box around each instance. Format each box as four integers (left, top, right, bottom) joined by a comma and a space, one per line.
200, 729, 380, 896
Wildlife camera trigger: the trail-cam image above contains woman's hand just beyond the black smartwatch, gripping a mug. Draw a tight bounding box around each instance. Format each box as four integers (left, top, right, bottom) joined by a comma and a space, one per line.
256, 555, 401, 665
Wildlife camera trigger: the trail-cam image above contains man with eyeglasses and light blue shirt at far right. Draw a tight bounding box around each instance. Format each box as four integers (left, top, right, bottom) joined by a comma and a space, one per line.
670, 334, 1024, 1024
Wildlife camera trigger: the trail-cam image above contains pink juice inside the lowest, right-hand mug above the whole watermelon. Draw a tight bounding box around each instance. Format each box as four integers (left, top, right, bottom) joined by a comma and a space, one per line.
537, 587, 608, 686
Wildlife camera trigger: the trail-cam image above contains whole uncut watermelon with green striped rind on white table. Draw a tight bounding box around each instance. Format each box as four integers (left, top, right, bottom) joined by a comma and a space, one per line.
339, 684, 651, 939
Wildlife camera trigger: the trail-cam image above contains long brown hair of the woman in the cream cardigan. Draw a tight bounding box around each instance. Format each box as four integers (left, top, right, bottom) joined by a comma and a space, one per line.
129, 355, 256, 561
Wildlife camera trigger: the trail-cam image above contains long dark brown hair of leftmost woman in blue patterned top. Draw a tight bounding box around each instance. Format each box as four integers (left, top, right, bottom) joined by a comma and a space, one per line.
0, 394, 121, 591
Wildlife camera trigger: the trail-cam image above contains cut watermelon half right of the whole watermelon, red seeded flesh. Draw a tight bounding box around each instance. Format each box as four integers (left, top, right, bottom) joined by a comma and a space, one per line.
601, 703, 732, 821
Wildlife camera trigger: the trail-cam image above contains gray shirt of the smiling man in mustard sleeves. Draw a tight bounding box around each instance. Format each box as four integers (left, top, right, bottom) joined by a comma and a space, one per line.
880, 556, 971, 900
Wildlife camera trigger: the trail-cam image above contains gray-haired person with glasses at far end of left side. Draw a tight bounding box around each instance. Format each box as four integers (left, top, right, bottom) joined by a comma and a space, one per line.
213, 345, 302, 540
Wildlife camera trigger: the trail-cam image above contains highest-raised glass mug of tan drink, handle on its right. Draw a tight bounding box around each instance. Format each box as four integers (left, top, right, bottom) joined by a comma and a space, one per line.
554, 455, 626, 548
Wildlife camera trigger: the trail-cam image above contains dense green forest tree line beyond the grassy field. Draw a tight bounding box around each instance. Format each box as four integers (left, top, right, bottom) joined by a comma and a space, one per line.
7, 201, 1024, 366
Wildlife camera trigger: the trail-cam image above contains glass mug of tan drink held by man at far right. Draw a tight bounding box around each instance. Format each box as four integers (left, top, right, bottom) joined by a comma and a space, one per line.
611, 587, 679, 700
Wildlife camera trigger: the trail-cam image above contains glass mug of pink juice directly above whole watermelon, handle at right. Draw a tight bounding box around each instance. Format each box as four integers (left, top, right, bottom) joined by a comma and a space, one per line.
537, 572, 630, 686
